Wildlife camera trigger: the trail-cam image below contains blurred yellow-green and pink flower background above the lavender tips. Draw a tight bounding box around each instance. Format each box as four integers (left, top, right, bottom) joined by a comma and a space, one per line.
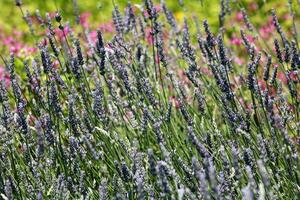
0, 0, 300, 55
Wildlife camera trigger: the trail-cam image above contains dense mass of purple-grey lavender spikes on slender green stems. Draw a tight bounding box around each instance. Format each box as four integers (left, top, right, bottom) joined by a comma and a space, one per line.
0, 0, 300, 200
